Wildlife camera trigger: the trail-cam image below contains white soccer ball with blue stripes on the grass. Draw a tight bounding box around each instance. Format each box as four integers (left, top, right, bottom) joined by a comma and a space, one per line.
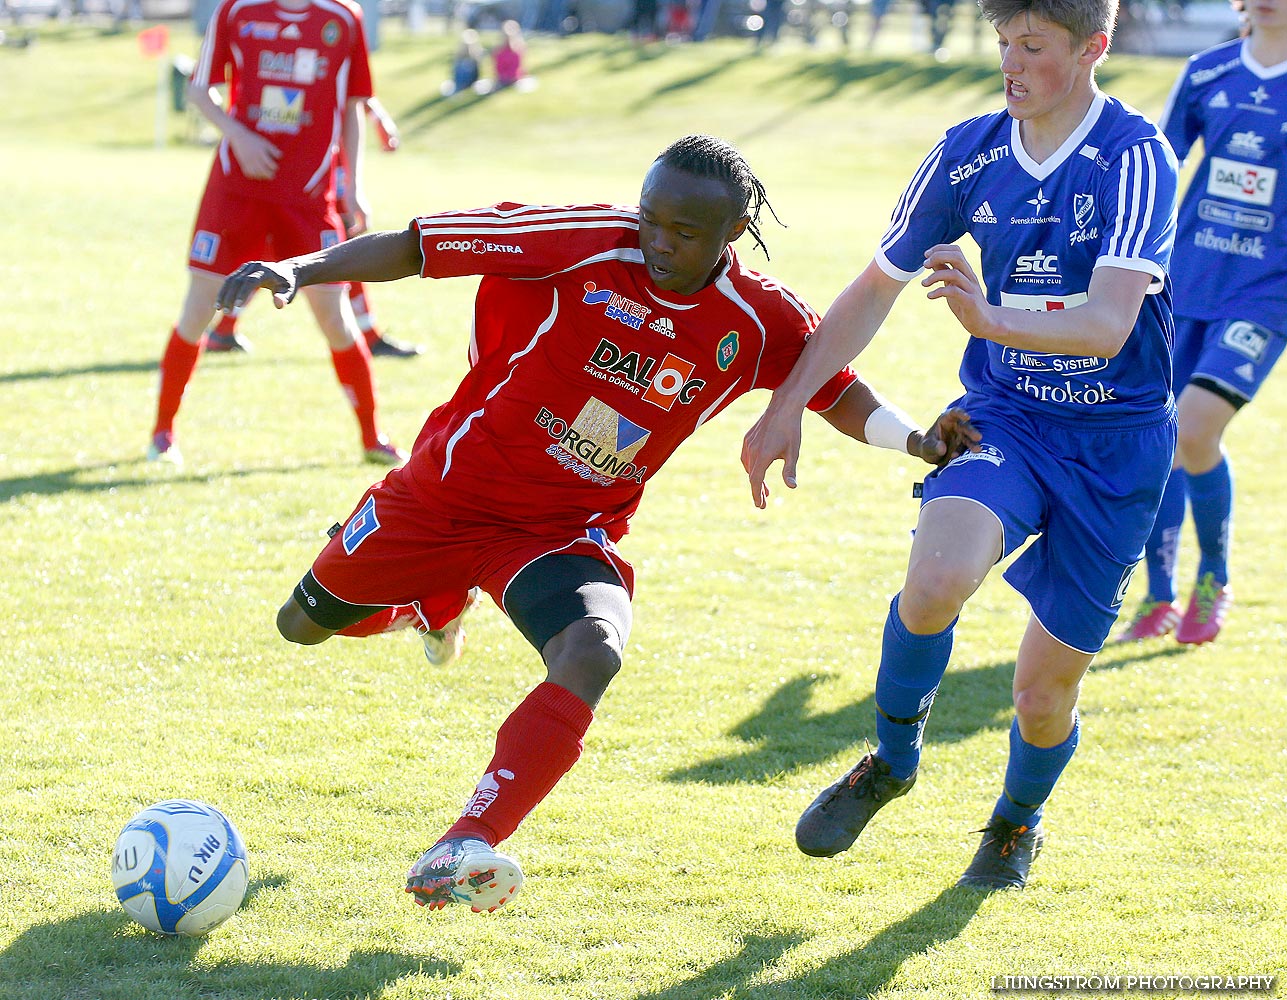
112, 799, 250, 937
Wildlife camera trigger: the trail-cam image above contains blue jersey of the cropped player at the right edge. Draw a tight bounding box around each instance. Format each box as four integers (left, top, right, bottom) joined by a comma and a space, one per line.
1162, 40, 1287, 331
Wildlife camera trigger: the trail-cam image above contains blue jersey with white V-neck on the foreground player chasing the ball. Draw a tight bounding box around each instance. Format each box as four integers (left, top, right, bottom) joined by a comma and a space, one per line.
876, 93, 1178, 423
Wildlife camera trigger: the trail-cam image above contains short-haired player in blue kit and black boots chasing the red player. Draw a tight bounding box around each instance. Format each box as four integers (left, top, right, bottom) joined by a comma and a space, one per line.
743, 0, 1176, 889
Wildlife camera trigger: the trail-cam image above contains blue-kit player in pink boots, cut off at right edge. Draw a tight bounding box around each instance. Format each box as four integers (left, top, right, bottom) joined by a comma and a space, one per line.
1121, 0, 1287, 644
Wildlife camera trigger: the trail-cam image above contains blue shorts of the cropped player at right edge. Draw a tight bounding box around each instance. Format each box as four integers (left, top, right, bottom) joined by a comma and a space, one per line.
1175, 317, 1287, 409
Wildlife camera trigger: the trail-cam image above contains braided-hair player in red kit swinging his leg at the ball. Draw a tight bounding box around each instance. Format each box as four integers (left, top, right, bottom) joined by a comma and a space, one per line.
219, 135, 977, 910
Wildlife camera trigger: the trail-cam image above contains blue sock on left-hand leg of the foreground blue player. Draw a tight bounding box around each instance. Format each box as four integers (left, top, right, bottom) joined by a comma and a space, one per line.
876, 595, 956, 779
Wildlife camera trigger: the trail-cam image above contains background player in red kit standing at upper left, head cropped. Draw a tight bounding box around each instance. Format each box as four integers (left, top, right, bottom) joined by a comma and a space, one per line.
148, 0, 405, 465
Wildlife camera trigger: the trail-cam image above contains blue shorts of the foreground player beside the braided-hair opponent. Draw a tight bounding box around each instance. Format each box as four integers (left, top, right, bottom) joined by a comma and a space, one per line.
923, 396, 1176, 653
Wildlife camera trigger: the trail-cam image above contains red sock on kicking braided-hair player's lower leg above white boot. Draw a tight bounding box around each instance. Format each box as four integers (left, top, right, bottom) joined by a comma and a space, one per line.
443, 681, 595, 847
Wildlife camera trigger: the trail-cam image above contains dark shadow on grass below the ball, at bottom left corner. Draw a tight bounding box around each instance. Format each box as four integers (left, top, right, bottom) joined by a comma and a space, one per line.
0, 906, 461, 1000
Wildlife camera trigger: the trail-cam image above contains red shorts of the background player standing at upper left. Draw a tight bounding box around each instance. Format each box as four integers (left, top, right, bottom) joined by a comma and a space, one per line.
188, 163, 345, 275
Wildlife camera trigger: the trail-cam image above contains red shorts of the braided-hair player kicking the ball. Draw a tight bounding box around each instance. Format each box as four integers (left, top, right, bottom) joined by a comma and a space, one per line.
301, 468, 634, 628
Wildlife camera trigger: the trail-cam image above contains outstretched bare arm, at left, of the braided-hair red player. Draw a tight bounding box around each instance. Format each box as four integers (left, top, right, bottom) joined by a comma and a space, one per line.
215, 229, 421, 311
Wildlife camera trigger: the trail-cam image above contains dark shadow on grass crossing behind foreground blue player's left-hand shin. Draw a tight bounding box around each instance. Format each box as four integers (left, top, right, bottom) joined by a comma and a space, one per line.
667, 659, 1014, 785
